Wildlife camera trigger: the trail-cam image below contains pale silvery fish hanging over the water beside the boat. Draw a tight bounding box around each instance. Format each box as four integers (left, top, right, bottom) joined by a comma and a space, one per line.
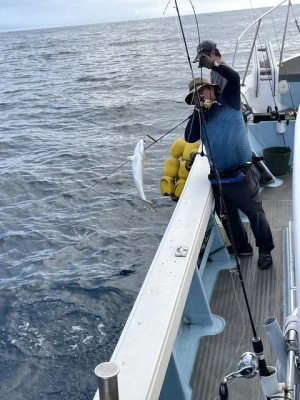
129, 139, 155, 210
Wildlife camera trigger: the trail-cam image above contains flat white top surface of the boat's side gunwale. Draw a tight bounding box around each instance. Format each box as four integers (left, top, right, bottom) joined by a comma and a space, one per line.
94, 155, 213, 400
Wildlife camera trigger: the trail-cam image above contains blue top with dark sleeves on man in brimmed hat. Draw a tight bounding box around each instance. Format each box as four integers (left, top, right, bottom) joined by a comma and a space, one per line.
185, 64, 252, 170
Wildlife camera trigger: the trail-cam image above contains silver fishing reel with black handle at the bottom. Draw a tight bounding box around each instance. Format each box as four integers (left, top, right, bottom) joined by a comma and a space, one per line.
219, 351, 258, 400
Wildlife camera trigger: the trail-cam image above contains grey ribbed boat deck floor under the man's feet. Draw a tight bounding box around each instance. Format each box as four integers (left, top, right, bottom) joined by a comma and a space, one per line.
191, 171, 292, 400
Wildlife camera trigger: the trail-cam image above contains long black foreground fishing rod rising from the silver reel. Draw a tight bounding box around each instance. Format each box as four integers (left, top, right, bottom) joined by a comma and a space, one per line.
174, 0, 270, 390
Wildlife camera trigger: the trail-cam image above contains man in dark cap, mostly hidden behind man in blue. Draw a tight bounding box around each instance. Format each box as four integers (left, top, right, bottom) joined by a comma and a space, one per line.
193, 40, 274, 186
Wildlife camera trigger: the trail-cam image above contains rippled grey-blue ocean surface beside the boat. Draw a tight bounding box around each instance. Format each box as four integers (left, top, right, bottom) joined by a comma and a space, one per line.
0, 6, 300, 400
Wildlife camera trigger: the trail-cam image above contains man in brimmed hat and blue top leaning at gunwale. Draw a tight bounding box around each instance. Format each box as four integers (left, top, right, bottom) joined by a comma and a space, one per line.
185, 54, 274, 269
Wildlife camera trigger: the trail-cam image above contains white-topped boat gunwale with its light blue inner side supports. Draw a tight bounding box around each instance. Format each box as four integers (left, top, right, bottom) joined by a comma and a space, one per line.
94, 156, 233, 400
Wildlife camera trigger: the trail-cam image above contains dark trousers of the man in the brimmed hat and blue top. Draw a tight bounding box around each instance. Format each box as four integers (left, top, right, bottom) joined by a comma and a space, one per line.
213, 166, 274, 250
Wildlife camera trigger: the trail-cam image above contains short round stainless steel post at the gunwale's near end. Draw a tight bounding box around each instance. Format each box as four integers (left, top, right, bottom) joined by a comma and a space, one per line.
95, 362, 120, 400
